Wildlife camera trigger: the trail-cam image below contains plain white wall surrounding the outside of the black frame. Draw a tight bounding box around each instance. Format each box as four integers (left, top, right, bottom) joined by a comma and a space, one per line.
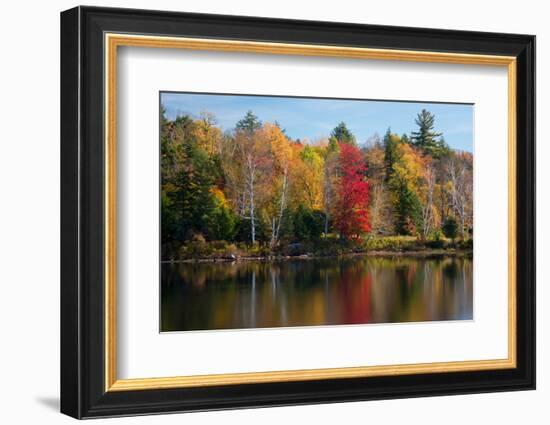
0, 0, 550, 425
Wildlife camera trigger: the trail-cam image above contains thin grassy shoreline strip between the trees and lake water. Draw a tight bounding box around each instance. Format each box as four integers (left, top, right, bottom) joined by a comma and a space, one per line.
160, 249, 473, 264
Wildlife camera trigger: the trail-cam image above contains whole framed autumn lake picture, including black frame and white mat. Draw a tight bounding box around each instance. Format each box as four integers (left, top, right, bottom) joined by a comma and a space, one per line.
61, 7, 535, 418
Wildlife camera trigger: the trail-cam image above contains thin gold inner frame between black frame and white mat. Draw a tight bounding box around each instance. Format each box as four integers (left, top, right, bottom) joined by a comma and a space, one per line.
104, 33, 517, 391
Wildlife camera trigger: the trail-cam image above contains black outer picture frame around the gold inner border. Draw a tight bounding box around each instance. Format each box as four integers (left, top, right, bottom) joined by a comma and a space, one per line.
61, 7, 535, 418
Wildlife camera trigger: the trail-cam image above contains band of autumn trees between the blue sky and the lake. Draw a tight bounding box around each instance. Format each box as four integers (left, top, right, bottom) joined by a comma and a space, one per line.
161, 109, 473, 258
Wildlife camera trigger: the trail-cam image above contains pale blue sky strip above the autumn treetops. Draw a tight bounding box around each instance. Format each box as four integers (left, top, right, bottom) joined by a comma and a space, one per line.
161, 92, 473, 152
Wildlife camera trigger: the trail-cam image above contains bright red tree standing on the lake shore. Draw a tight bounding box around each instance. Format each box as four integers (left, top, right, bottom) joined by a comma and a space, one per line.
334, 143, 371, 239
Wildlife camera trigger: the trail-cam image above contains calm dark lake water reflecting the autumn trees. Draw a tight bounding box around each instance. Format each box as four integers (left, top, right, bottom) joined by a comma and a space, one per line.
161, 256, 473, 332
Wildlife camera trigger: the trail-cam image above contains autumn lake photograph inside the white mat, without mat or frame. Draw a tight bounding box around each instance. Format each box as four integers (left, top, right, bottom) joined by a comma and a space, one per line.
159, 91, 474, 332
